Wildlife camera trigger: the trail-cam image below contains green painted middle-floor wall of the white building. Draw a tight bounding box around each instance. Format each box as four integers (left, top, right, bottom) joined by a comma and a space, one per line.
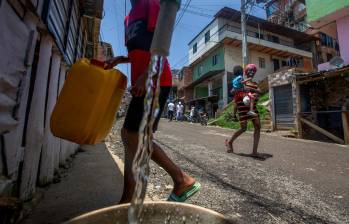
193, 48, 224, 80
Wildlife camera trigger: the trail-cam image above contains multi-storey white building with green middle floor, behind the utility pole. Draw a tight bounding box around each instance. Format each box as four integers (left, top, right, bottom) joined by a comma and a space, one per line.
187, 8, 313, 114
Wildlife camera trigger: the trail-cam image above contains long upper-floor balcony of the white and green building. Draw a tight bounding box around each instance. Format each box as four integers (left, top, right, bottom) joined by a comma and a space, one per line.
219, 24, 313, 58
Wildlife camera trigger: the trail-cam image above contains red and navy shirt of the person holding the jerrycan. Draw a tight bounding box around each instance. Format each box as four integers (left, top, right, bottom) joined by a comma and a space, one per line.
125, 0, 172, 86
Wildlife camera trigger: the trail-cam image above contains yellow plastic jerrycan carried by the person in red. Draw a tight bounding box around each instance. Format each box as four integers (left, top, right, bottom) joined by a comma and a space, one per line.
50, 59, 127, 145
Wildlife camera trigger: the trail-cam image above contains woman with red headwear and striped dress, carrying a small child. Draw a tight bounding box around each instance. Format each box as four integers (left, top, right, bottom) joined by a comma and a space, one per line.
226, 64, 261, 157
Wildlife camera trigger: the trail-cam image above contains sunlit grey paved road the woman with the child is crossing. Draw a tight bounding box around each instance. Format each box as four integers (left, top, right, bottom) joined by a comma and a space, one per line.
109, 121, 349, 223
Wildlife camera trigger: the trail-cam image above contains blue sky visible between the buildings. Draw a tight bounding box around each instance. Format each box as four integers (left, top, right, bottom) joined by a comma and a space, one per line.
101, 0, 265, 80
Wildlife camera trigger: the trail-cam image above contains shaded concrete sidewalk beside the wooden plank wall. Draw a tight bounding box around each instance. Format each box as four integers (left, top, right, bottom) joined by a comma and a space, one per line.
22, 144, 123, 224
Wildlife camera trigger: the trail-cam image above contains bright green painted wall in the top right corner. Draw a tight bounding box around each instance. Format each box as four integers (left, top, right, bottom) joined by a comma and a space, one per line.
306, 0, 349, 22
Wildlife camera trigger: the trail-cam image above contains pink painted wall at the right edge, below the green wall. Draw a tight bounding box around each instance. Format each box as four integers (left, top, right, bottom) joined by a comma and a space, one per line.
337, 16, 349, 64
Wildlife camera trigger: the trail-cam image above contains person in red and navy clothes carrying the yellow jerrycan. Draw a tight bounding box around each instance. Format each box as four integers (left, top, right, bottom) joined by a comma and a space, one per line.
105, 0, 201, 203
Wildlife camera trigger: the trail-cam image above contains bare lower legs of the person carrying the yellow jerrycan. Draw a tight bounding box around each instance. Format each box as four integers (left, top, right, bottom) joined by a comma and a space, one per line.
120, 129, 195, 204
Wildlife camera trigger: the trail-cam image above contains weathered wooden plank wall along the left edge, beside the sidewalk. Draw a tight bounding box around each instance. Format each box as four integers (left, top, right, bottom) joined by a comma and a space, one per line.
0, 0, 93, 200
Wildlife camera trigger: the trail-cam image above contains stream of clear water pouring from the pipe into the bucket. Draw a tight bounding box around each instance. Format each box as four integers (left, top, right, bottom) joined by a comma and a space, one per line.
128, 55, 165, 224
